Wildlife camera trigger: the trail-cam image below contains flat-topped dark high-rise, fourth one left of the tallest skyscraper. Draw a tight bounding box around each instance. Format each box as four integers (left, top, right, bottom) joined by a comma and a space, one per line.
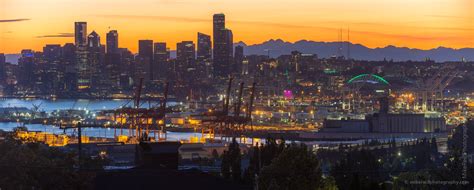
138, 40, 153, 80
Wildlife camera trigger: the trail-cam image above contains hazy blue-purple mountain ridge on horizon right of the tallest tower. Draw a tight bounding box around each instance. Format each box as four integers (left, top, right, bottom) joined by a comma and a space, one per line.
234, 39, 474, 62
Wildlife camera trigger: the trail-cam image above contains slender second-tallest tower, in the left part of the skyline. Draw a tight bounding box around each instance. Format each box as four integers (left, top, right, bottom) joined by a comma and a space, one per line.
74, 22, 91, 92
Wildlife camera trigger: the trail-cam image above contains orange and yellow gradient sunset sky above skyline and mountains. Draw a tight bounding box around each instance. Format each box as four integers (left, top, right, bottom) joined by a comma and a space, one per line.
0, 0, 474, 53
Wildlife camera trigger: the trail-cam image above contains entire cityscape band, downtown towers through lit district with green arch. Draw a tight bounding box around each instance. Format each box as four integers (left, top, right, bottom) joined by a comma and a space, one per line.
0, 14, 474, 125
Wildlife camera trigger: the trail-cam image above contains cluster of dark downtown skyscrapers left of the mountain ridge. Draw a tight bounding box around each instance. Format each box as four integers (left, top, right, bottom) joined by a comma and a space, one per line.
0, 14, 237, 97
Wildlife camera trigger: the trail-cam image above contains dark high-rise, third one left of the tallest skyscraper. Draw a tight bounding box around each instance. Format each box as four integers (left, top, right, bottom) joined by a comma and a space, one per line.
153, 42, 170, 79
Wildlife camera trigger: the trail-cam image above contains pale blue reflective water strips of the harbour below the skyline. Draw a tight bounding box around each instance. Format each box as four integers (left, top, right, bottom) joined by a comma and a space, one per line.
0, 99, 422, 145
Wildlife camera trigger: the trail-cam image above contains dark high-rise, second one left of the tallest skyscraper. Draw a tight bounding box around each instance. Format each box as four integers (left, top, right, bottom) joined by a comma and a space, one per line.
176, 41, 196, 67
